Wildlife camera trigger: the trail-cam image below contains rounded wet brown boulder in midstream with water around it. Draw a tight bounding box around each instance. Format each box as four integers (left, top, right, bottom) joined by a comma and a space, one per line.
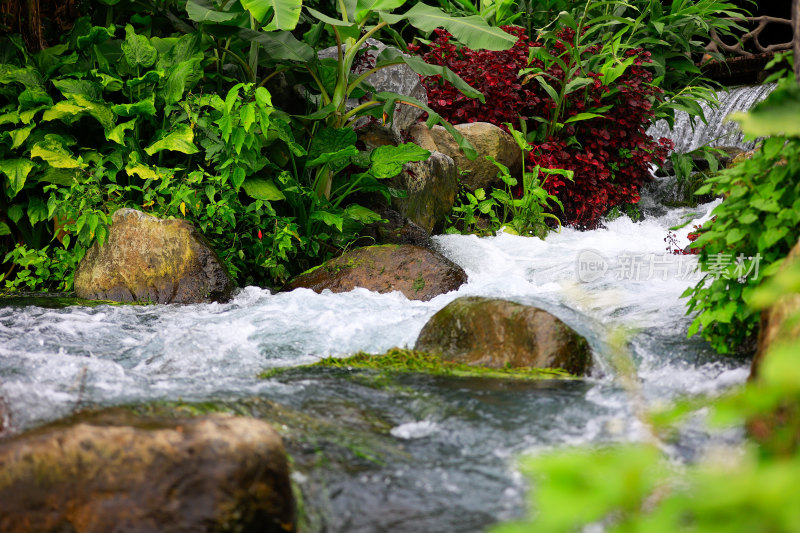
414, 296, 592, 375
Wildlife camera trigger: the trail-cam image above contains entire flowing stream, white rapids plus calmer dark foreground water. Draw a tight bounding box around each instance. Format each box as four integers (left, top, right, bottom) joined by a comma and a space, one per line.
0, 85, 764, 532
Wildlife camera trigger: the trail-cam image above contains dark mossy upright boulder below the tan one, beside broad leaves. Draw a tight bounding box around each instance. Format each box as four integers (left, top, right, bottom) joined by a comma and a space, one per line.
391, 152, 458, 233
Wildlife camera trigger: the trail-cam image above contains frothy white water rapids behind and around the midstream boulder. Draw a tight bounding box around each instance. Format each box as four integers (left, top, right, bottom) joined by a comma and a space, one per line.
0, 197, 747, 427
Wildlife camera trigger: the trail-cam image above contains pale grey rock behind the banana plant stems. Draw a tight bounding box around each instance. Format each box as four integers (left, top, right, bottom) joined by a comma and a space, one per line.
318, 39, 428, 139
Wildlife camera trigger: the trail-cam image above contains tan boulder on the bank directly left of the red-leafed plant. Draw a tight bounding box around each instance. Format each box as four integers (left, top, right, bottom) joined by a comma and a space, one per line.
409, 122, 522, 191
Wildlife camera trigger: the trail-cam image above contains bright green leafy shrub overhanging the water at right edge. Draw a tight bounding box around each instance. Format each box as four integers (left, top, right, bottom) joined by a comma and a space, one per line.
684, 74, 800, 353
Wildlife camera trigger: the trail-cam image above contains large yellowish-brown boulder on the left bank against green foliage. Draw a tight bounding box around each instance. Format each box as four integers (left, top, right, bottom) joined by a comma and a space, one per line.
75, 209, 233, 303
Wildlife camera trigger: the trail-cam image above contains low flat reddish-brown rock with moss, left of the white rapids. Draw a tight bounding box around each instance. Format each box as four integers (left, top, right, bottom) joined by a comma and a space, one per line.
287, 245, 467, 300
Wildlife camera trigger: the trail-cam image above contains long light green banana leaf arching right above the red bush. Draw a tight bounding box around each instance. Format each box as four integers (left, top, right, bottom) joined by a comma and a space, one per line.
392, 3, 517, 50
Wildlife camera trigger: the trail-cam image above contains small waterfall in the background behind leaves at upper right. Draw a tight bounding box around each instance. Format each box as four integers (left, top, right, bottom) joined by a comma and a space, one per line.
647, 84, 775, 153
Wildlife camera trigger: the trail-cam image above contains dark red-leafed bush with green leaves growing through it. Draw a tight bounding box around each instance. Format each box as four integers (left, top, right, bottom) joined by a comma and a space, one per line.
410, 26, 672, 228
